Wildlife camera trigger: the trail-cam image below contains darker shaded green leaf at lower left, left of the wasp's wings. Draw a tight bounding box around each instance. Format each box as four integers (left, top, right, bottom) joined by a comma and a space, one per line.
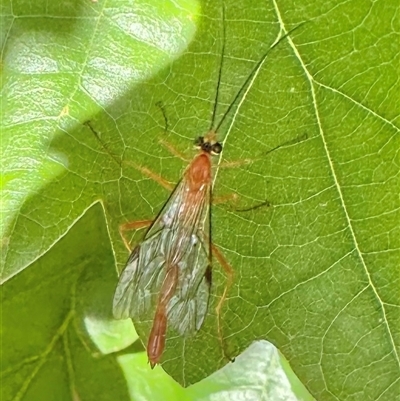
1, 205, 134, 400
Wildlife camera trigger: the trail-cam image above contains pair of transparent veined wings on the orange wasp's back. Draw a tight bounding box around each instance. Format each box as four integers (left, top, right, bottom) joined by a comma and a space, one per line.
113, 170, 211, 334
